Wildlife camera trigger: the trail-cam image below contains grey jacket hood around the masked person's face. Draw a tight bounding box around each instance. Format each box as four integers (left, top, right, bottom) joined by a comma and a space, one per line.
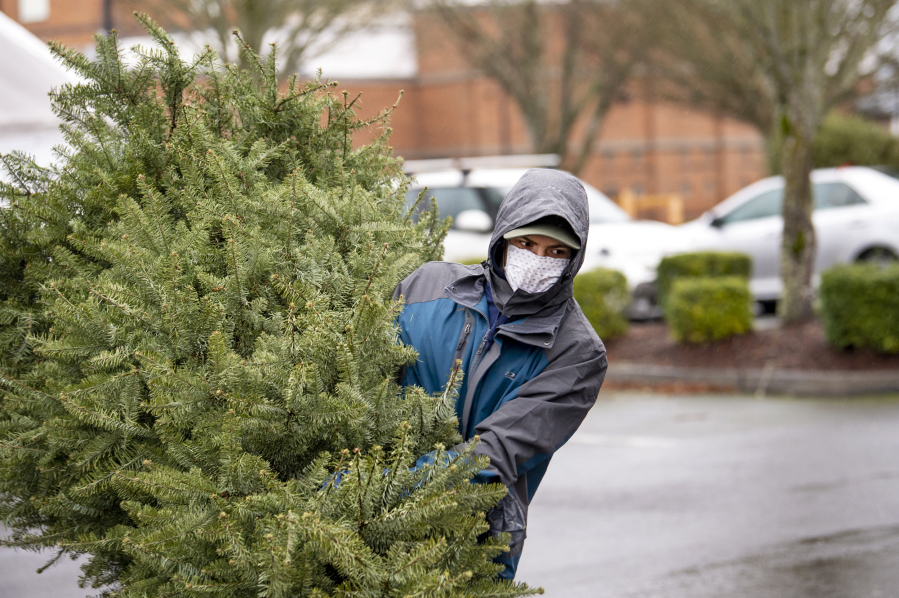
487, 168, 590, 317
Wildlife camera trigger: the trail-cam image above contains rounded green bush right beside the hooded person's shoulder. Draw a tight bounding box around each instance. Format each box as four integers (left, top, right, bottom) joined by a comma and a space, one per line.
574, 268, 631, 340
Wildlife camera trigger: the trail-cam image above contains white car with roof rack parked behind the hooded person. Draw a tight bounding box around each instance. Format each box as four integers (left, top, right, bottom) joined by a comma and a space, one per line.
407, 168, 684, 316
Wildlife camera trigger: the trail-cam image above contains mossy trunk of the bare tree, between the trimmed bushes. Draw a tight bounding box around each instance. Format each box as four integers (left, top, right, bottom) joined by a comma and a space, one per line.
779, 126, 815, 324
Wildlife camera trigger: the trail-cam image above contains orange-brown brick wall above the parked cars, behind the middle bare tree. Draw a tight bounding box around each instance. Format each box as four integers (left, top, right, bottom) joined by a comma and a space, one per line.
404, 13, 767, 218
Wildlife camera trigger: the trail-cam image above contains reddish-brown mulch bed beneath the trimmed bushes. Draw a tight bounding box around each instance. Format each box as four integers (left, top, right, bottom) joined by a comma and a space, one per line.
606, 322, 899, 370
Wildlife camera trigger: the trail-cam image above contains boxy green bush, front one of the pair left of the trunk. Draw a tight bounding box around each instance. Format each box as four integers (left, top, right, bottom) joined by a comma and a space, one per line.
664, 276, 752, 343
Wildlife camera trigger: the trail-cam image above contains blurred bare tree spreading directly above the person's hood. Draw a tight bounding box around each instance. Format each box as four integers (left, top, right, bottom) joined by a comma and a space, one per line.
423, 0, 647, 173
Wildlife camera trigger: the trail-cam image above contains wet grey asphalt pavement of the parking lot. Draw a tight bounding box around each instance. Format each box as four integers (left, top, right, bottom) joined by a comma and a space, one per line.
0, 392, 899, 598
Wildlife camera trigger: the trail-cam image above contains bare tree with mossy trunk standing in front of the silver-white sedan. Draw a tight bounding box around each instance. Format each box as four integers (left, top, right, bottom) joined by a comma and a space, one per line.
655, 0, 897, 323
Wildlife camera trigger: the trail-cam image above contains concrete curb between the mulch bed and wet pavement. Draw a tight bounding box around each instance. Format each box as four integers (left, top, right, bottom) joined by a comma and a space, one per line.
606, 362, 899, 397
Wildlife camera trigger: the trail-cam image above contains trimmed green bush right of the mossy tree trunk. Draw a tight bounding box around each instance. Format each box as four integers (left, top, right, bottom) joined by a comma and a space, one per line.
818, 264, 899, 353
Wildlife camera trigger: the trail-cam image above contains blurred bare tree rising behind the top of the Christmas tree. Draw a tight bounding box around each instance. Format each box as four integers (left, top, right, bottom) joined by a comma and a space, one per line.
128, 0, 400, 77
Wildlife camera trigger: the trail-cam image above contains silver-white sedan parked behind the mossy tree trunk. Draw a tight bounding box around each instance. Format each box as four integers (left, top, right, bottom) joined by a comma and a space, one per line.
678, 167, 899, 301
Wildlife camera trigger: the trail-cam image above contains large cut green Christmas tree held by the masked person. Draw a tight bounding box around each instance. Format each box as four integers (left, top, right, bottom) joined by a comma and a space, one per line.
0, 17, 533, 597
